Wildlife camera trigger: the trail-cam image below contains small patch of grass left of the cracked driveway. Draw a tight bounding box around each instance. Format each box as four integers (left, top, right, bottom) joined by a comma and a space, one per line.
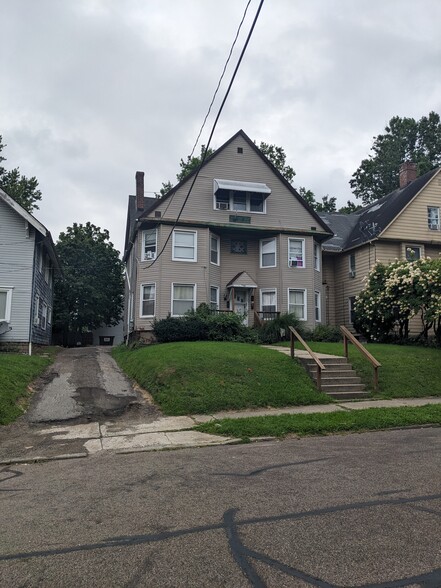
0, 348, 55, 425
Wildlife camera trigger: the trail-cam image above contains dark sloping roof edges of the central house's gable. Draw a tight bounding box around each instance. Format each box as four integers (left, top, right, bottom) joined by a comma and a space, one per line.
136, 129, 332, 234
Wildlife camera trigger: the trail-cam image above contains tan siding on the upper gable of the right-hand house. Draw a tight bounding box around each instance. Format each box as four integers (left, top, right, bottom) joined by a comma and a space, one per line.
381, 173, 441, 245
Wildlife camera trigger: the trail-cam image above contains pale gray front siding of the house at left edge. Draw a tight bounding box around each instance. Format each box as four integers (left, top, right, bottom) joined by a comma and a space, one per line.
0, 201, 35, 343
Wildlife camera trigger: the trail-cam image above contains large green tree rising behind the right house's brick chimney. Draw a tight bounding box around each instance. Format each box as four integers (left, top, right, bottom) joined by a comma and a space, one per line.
349, 111, 441, 205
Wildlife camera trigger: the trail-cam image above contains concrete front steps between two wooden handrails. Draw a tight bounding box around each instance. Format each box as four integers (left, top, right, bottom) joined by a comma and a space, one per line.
299, 354, 370, 400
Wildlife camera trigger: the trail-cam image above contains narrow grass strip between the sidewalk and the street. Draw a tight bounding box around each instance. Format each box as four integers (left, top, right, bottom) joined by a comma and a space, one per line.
195, 404, 441, 439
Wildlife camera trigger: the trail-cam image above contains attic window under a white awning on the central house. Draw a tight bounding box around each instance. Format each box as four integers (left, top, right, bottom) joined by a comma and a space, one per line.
214, 180, 271, 213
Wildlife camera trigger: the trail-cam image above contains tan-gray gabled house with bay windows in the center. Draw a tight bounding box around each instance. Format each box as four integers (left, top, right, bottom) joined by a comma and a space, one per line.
124, 131, 332, 339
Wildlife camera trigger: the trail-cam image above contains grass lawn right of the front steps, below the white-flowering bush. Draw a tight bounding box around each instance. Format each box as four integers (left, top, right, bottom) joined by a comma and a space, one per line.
280, 342, 441, 398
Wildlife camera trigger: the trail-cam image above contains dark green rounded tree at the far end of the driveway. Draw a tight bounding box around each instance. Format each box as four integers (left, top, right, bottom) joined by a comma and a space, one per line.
54, 222, 124, 332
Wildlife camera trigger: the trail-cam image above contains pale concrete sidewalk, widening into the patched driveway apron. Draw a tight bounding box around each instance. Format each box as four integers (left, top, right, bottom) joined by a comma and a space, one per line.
0, 397, 441, 465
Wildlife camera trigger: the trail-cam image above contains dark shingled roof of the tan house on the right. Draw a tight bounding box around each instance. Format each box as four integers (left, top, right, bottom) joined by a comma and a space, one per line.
320, 168, 441, 251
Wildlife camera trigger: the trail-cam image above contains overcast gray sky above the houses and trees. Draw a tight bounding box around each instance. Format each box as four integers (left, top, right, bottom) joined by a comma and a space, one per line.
0, 0, 441, 250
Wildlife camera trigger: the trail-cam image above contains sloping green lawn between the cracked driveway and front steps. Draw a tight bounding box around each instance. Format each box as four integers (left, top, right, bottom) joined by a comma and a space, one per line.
113, 341, 331, 415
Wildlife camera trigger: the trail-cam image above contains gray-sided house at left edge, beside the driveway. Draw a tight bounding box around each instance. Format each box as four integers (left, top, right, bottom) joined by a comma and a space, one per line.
0, 189, 60, 351
